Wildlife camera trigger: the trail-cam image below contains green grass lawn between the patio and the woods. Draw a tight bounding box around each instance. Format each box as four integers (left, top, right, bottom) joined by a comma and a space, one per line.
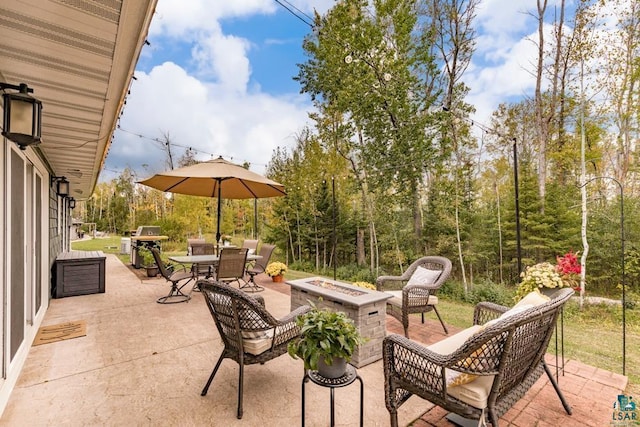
71, 236, 640, 394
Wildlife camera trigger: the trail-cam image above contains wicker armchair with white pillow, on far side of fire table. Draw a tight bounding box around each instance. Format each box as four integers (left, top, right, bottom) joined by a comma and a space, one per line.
376, 256, 451, 338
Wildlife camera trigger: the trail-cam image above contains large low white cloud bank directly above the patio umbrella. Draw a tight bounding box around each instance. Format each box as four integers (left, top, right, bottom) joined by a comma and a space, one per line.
108, 62, 308, 175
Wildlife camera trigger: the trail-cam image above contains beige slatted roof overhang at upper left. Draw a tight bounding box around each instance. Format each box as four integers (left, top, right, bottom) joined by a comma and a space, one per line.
0, 0, 157, 199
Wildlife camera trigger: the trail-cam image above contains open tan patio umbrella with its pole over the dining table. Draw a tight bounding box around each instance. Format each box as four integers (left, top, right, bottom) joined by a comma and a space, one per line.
139, 157, 286, 242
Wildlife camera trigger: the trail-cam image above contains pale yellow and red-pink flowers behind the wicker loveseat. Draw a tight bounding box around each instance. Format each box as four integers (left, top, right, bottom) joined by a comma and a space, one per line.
514, 251, 581, 301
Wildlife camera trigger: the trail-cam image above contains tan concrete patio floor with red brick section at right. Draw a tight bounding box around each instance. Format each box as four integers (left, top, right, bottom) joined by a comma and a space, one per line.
0, 255, 627, 427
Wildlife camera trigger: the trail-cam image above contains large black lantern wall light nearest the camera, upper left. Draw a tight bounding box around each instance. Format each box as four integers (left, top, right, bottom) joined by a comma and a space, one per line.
0, 82, 42, 150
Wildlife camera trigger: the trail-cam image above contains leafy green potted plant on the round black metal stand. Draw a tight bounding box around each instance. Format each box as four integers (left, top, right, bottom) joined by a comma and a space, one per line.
287, 304, 364, 378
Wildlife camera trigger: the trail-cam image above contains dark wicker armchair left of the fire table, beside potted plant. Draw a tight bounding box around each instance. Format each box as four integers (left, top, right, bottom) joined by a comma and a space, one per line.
198, 280, 310, 419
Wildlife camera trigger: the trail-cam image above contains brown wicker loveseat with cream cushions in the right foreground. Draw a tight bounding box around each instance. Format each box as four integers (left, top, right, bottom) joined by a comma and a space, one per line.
383, 288, 573, 427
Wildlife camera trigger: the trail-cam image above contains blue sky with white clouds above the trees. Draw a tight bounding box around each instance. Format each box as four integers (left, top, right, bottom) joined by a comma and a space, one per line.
101, 0, 568, 180
